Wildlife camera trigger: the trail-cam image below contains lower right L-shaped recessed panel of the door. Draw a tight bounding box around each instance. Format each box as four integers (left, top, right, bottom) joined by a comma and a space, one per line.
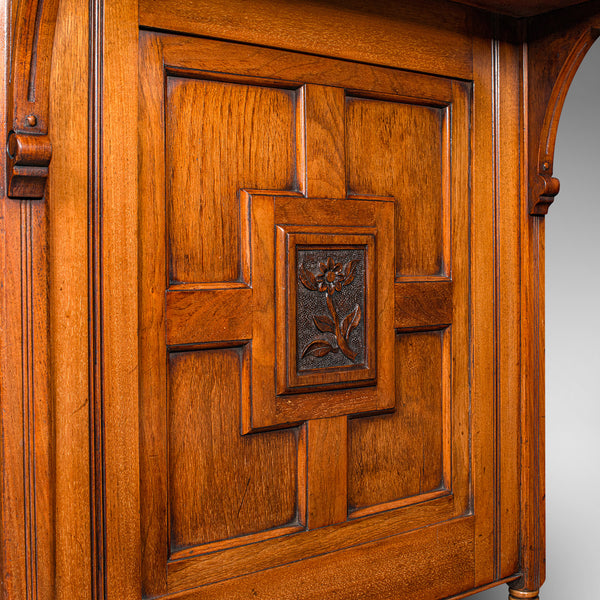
348, 331, 446, 510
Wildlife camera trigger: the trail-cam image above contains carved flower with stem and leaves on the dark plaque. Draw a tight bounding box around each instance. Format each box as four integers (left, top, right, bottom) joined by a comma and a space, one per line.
298, 257, 362, 360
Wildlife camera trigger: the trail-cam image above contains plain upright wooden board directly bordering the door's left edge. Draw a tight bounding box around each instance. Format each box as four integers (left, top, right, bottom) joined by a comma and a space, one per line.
103, 0, 141, 598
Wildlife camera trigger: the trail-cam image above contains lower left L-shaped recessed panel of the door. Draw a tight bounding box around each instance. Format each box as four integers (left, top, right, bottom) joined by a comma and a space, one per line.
168, 348, 298, 551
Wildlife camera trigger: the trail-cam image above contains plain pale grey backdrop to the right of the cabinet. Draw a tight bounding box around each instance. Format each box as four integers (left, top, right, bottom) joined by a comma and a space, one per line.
472, 36, 600, 600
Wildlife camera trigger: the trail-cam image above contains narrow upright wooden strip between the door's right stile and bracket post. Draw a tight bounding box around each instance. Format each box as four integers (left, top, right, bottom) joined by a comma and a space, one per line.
496, 34, 527, 577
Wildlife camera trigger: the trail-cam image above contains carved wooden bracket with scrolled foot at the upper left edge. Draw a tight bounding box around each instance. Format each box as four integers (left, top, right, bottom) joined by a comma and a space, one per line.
6, 0, 60, 199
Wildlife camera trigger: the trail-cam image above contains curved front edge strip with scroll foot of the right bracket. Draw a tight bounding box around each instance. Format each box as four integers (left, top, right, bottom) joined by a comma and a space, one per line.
530, 27, 600, 216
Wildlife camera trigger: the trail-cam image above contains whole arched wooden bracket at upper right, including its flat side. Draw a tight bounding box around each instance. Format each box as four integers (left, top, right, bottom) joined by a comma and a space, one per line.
528, 9, 600, 216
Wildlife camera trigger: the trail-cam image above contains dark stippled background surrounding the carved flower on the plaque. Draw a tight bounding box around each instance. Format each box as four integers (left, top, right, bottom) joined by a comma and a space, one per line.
296, 246, 366, 373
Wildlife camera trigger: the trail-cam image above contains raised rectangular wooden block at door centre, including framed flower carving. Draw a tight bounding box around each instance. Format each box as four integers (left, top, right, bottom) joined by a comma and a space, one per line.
242, 192, 395, 432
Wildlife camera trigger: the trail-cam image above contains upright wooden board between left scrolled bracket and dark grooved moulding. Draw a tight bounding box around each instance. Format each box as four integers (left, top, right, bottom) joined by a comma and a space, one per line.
48, 0, 92, 600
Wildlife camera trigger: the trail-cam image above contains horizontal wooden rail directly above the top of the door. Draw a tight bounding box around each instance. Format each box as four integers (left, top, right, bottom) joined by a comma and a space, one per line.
140, 0, 472, 79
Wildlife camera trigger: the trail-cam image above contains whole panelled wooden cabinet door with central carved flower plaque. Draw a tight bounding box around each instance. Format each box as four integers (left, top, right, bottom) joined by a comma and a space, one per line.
138, 32, 492, 600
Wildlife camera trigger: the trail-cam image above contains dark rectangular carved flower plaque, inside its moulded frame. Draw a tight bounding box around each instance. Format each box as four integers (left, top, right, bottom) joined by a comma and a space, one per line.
296, 248, 365, 371
